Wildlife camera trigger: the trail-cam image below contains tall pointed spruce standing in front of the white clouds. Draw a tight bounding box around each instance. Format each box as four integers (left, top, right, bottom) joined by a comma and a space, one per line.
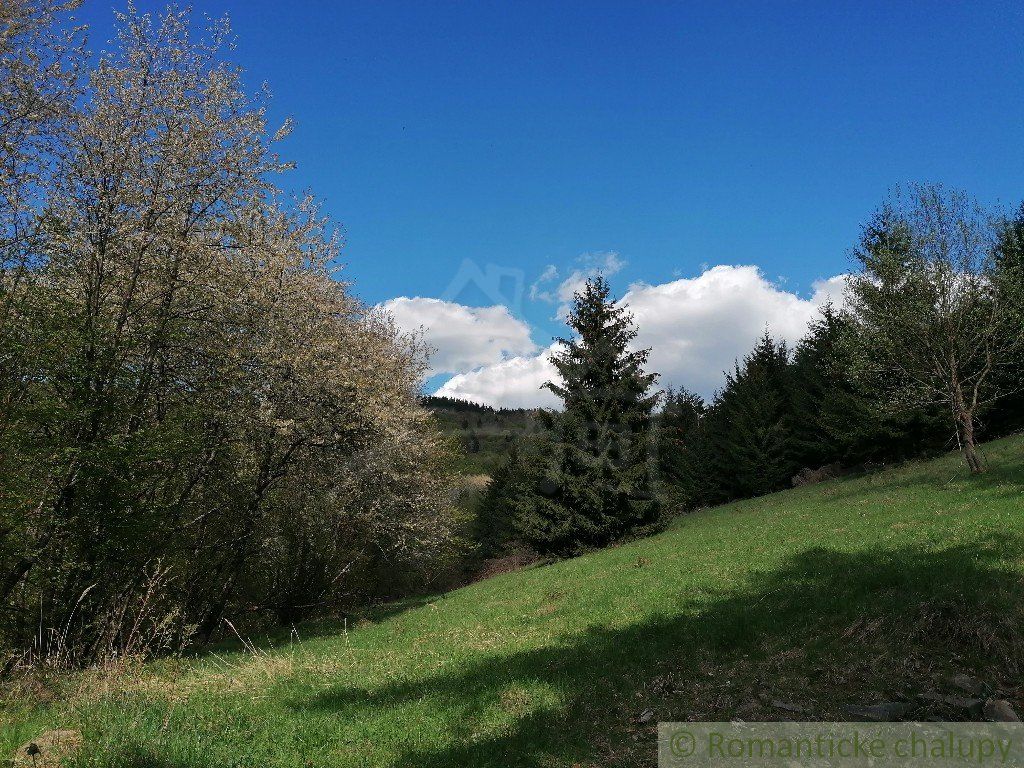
517, 276, 662, 555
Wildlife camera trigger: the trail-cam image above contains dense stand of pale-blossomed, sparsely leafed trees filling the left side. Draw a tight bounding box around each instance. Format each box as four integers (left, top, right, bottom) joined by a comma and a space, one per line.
0, 0, 457, 667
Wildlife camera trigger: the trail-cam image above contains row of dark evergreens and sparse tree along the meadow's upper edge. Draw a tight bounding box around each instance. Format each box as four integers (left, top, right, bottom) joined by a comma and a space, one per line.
477, 191, 1024, 556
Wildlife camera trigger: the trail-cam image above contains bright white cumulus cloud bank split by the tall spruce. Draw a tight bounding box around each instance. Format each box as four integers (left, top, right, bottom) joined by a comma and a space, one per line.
437, 265, 845, 408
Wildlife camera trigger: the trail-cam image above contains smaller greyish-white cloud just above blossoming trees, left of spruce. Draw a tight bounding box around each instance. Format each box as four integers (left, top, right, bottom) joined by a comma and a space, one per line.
380, 296, 537, 376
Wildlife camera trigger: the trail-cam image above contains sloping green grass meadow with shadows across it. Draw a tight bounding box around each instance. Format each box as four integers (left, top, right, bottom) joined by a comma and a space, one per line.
0, 437, 1024, 768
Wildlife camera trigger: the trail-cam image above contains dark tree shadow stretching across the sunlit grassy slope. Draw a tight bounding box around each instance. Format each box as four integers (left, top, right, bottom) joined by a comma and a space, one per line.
291, 539, 1024, 766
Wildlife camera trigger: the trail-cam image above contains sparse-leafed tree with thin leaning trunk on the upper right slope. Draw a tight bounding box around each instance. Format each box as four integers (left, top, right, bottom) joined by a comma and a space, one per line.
850, 185, 1024, 472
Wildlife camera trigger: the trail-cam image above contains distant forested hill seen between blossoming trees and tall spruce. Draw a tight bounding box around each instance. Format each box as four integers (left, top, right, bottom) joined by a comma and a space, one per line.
423, 396, 541, 475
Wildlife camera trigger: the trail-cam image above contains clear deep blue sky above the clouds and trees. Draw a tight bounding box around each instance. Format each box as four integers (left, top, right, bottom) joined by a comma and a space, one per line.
79, 0, 1024, 403
